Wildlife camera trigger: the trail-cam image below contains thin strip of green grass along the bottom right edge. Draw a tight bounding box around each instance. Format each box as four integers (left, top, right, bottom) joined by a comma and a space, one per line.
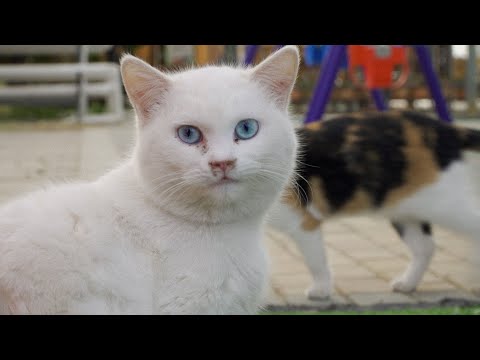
262, 306, 480, 315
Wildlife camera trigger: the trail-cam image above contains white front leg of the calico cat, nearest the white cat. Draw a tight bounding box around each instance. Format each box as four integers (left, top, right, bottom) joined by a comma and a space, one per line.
270, 204, 332, 300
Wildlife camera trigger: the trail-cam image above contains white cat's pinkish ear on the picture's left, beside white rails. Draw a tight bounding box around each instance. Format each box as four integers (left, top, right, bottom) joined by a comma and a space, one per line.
120, 55, 171, 126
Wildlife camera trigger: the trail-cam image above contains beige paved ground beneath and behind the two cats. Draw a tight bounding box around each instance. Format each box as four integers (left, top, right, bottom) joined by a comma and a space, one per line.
0, 116, 480, 308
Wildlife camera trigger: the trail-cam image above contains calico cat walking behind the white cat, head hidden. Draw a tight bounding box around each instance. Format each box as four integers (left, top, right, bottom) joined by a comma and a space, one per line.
271, 111, 480, 299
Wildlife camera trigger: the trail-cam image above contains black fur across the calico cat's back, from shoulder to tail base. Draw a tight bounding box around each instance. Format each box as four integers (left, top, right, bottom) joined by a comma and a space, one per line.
297, 111, 467, 212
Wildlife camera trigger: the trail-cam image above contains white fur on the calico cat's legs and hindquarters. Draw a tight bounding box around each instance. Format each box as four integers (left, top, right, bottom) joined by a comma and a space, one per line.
269, 160, 480, 299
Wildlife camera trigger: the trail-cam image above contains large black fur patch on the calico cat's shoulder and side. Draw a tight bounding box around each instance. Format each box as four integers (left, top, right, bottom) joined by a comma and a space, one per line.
299, 113, 405, 211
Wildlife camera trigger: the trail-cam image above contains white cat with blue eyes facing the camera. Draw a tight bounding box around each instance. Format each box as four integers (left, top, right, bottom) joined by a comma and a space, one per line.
0, 46, 299, 314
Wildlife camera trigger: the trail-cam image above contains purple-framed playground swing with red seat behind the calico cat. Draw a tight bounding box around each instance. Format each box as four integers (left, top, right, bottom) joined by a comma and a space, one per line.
245, 45, 452, 123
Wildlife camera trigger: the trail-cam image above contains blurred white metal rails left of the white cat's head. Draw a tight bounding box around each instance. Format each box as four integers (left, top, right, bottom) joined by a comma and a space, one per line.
0, 45, 124, 123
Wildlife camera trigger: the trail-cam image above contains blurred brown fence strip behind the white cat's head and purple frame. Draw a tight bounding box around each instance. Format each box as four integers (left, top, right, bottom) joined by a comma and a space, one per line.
124, 45, 480, 117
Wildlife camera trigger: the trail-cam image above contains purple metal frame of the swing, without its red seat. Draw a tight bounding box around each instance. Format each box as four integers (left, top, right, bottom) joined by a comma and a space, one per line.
245, 45, 453, 123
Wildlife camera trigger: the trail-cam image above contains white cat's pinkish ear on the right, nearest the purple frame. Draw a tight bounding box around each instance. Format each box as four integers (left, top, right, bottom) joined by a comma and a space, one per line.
252, 45, 300, 110
